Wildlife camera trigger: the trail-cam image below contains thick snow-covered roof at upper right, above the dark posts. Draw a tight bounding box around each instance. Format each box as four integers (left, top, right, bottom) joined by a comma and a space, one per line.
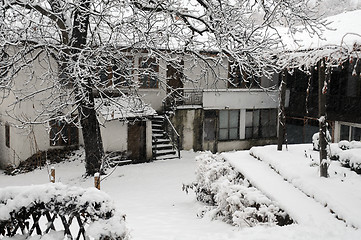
278, 10, 361, 67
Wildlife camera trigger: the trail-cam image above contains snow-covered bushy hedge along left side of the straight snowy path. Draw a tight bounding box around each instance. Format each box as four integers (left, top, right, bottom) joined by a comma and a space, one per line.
185, 153, 293, 226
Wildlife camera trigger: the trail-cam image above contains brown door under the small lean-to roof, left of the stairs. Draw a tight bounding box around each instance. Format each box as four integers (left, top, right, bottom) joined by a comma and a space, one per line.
128, 121, 147, 163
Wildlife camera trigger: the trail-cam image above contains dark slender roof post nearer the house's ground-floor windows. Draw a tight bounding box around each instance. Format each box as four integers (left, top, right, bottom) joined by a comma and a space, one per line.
277, 70, 287, 151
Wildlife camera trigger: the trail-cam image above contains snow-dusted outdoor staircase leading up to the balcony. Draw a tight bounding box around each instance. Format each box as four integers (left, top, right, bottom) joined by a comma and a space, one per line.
152, 115, 179, 160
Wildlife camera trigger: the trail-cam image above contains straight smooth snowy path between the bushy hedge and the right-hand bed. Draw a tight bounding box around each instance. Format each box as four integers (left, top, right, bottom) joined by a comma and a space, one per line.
222, 151, 344, 227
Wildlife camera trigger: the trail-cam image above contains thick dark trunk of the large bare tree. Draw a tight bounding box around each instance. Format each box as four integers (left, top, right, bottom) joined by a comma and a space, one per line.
71, 0, 104, 176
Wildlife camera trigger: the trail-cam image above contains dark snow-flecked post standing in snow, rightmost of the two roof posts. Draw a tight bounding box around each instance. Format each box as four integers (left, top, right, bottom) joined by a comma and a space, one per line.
318, 59, 328, 177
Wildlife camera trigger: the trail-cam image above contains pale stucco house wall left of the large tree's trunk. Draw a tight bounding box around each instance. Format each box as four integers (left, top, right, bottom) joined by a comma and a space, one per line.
0, 48, 56, 167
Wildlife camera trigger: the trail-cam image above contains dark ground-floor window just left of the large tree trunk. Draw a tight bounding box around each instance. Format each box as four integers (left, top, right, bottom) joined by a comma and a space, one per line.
50, 120, 79, 146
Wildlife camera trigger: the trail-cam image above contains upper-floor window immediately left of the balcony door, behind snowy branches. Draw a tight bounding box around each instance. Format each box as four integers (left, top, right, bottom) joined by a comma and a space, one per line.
139, 57, 159, 88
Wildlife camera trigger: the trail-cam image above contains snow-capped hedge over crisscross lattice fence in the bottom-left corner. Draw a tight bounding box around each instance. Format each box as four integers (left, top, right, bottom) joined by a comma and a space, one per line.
0, 183, 128, 239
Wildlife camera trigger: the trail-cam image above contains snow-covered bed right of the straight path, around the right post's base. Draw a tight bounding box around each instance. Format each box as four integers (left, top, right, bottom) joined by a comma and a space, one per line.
252, 144, 361, 229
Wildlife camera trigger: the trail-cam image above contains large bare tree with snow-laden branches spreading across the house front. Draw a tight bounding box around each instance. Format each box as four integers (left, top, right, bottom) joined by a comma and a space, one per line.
0, 0, 322, 174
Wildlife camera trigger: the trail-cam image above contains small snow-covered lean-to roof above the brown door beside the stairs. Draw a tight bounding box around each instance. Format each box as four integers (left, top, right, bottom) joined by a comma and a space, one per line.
95, 97, 156, 121
